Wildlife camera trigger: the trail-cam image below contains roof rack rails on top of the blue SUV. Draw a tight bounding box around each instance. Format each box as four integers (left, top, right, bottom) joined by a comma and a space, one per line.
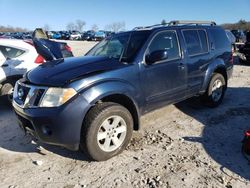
133, 20, 216, 30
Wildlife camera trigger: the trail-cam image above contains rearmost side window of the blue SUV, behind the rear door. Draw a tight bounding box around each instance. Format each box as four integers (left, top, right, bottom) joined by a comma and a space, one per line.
211, 29, 230, 49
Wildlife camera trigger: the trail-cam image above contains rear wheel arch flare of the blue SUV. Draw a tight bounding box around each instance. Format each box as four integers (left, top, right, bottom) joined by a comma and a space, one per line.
200, 58, 226, 94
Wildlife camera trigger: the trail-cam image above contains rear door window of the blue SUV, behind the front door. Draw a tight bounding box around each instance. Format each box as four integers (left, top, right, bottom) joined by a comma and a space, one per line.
183, 29, 208, 56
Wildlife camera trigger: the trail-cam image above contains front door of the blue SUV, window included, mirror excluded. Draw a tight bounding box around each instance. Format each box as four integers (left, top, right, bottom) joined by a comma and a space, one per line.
141, 30, 187, 111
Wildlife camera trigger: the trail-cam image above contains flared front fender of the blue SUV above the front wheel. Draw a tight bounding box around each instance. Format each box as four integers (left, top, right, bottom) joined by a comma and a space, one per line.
70, 79, 144, 130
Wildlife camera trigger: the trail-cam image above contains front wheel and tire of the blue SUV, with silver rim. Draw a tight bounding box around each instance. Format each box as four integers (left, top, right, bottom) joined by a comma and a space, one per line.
80, 102, 133, 161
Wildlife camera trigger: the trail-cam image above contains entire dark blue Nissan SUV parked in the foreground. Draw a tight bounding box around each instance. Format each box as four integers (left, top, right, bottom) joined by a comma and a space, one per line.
13, 21, 233, 161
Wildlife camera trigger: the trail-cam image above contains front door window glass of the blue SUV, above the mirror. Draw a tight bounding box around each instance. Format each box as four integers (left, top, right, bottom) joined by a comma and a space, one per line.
149, 31, 180, 59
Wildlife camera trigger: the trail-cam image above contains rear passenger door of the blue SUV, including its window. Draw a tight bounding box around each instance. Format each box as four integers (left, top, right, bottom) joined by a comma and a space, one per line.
182, 29, 211, 95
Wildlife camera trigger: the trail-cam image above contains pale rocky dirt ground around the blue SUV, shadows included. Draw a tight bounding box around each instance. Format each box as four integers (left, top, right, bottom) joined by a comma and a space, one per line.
0, 42, 250, 188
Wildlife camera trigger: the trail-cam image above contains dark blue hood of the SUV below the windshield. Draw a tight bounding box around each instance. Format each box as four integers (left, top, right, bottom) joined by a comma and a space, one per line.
25, 56, 126, 87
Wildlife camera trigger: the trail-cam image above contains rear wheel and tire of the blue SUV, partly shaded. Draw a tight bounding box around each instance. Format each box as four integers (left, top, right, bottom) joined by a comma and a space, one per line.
202, 73, 227, 108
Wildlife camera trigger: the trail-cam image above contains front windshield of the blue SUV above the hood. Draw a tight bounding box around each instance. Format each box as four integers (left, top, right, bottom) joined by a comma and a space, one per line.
86, 31, 149, 62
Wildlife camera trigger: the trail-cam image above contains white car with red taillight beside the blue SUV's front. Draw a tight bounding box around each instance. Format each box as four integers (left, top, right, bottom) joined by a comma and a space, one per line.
0, 39, 44, 100
